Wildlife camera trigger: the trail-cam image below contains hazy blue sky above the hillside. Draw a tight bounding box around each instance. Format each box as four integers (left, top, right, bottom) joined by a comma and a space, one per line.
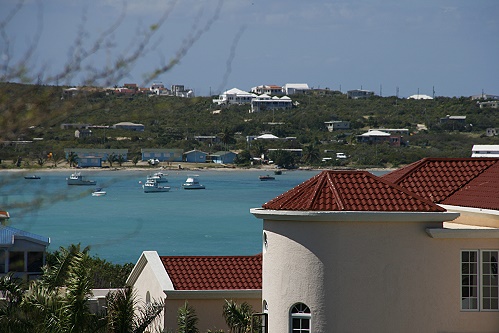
0, 0, 499, 97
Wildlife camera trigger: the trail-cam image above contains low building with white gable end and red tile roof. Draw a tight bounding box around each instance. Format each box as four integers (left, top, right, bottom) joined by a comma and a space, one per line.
127, 251, 262, 332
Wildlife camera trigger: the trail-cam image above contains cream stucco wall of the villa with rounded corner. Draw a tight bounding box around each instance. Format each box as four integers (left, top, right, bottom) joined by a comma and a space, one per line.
262, 219, 499, 333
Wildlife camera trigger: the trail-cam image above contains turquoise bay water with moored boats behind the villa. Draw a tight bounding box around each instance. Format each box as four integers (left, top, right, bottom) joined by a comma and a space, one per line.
0, 170, 386, 264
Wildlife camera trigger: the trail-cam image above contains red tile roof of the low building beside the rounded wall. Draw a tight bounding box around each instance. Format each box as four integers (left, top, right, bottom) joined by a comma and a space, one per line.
160, 254, 262, 290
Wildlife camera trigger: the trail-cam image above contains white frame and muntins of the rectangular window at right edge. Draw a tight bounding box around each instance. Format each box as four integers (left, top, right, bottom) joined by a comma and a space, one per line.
459, 249, 499, 312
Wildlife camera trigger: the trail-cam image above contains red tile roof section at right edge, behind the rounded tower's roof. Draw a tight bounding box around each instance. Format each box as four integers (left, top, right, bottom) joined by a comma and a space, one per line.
382, 157, 499, 210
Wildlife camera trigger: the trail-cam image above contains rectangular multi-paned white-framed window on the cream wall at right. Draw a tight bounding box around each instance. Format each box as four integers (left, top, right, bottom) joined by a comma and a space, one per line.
461, 250, 499, 311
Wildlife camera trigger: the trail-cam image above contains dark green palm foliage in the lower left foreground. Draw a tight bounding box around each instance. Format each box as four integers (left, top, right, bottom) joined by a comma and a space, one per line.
0, 241, 163, 333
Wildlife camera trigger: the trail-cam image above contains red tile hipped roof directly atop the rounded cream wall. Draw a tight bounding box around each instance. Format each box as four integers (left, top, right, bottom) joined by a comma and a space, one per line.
262, 171, 445, 212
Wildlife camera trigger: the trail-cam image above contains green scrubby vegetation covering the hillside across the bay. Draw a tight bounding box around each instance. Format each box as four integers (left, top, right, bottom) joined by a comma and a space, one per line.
0, 83, 499, 167
